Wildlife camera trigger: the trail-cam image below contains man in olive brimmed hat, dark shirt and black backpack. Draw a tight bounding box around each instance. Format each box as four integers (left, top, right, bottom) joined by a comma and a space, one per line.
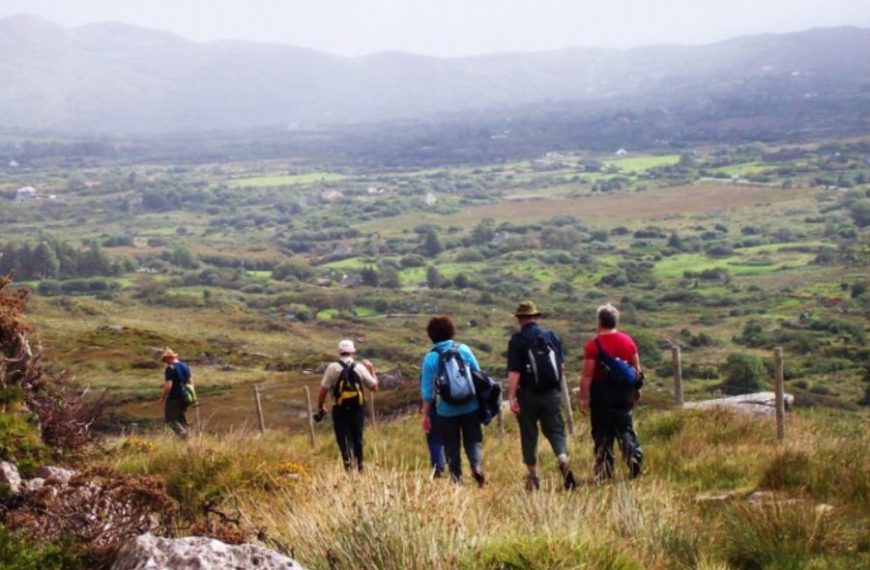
507, 301, 576, 490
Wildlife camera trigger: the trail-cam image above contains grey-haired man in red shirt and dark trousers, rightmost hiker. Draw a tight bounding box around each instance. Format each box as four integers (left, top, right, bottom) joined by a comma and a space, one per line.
580, 304, 643, 482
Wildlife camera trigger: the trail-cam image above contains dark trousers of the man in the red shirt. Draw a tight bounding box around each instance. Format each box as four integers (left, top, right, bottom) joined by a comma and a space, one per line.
590, 406, 643, 480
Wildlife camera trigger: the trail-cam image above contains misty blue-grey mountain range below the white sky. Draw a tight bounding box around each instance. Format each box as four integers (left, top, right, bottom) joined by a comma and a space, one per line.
0, 16, 870, 133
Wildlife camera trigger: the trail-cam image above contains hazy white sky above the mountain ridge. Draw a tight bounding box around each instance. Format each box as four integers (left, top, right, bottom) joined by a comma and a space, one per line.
0, 0, 870, 56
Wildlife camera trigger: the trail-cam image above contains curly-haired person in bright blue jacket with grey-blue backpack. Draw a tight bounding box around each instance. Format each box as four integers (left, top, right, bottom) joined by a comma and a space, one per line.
420, 315, 486, 487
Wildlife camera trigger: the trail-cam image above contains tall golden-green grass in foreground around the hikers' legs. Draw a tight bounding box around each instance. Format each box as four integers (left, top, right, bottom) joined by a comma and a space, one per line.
99, 411, 870, 570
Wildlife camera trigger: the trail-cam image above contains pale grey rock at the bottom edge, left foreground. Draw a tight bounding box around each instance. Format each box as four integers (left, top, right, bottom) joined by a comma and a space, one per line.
112, 534, 304, 570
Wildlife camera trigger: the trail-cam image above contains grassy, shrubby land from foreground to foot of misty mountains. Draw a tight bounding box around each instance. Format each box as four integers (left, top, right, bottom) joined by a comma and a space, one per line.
0, 131, 870, 569
